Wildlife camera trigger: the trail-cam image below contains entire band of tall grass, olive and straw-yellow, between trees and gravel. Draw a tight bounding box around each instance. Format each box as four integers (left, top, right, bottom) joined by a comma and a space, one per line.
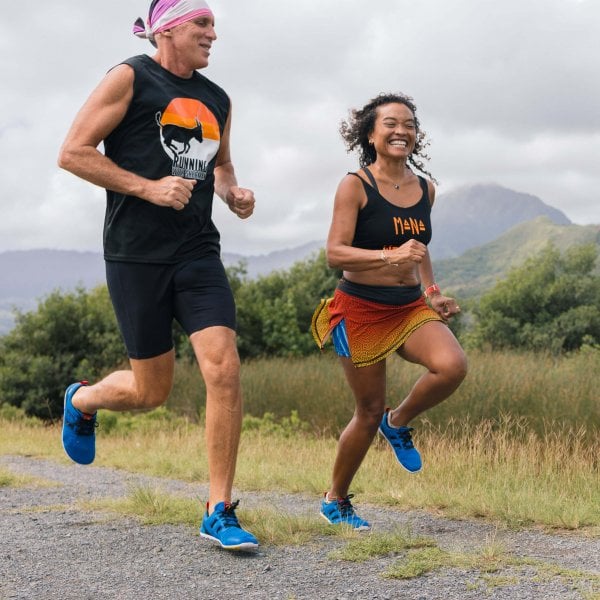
0, 352, 600, 532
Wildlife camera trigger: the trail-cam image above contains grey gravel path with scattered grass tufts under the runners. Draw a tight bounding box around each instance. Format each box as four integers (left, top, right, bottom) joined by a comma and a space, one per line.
0, 455, 600, 600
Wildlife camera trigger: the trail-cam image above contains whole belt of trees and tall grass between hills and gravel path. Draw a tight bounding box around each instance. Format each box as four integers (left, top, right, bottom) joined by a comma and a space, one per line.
0, 245, 600, 535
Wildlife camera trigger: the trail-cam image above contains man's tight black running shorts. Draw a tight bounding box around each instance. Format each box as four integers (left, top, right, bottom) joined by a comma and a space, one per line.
106, 254, 236, 359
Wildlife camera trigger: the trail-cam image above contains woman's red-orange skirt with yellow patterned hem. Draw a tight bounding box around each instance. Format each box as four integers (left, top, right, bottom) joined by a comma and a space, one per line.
311, 289, 443, 367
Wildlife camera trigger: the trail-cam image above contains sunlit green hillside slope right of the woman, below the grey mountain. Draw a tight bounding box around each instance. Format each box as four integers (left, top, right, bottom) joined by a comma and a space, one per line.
434, 217, 600, 299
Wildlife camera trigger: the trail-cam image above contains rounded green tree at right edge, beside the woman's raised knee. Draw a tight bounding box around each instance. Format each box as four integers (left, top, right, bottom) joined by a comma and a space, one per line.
470, 244, 600, 353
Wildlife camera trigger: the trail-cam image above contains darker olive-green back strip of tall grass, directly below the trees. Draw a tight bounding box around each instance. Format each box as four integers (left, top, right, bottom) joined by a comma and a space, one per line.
168, 351, 600, 436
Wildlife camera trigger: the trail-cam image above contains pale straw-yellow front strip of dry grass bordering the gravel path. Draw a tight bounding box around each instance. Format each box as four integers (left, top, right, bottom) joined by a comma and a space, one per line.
0, 419, 600, 534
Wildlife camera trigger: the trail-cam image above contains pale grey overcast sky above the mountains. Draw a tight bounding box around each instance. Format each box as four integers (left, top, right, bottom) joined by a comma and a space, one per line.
0, 0, 600, 255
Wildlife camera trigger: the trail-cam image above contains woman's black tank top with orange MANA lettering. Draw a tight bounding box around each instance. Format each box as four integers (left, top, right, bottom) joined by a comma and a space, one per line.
349, 168, 431, 250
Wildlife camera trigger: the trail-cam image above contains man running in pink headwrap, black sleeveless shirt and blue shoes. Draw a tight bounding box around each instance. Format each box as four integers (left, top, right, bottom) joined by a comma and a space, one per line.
58, 0, 258, 550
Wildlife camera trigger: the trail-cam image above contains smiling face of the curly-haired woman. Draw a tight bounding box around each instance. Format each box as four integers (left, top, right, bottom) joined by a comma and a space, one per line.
370, 102, 417, 159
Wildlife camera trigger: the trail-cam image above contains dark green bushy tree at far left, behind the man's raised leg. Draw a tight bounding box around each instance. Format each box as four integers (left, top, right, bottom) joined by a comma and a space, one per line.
0, 286, 127, 419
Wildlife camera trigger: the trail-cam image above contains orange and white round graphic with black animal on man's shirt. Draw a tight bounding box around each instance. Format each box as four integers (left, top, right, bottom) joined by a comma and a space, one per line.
156, 98, 221, 181
